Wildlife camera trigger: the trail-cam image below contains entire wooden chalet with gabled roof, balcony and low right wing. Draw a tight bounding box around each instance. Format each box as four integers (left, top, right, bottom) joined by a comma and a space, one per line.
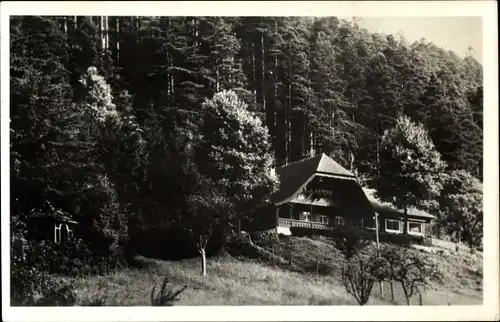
269, 154, 435, 244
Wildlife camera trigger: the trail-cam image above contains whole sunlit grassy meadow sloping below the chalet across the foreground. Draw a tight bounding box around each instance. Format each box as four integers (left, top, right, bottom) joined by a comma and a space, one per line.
56, 233, 482, 306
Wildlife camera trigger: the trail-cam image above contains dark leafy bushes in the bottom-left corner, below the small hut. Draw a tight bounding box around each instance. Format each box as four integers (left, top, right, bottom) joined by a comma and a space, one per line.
10, 216, 124, 306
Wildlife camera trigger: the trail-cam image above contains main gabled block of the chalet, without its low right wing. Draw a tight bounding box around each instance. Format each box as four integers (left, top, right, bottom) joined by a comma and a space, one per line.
273, 154, 374, 234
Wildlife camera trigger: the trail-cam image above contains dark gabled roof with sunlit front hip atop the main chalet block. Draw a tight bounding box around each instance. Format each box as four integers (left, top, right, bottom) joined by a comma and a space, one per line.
273, 153, 355, 203
